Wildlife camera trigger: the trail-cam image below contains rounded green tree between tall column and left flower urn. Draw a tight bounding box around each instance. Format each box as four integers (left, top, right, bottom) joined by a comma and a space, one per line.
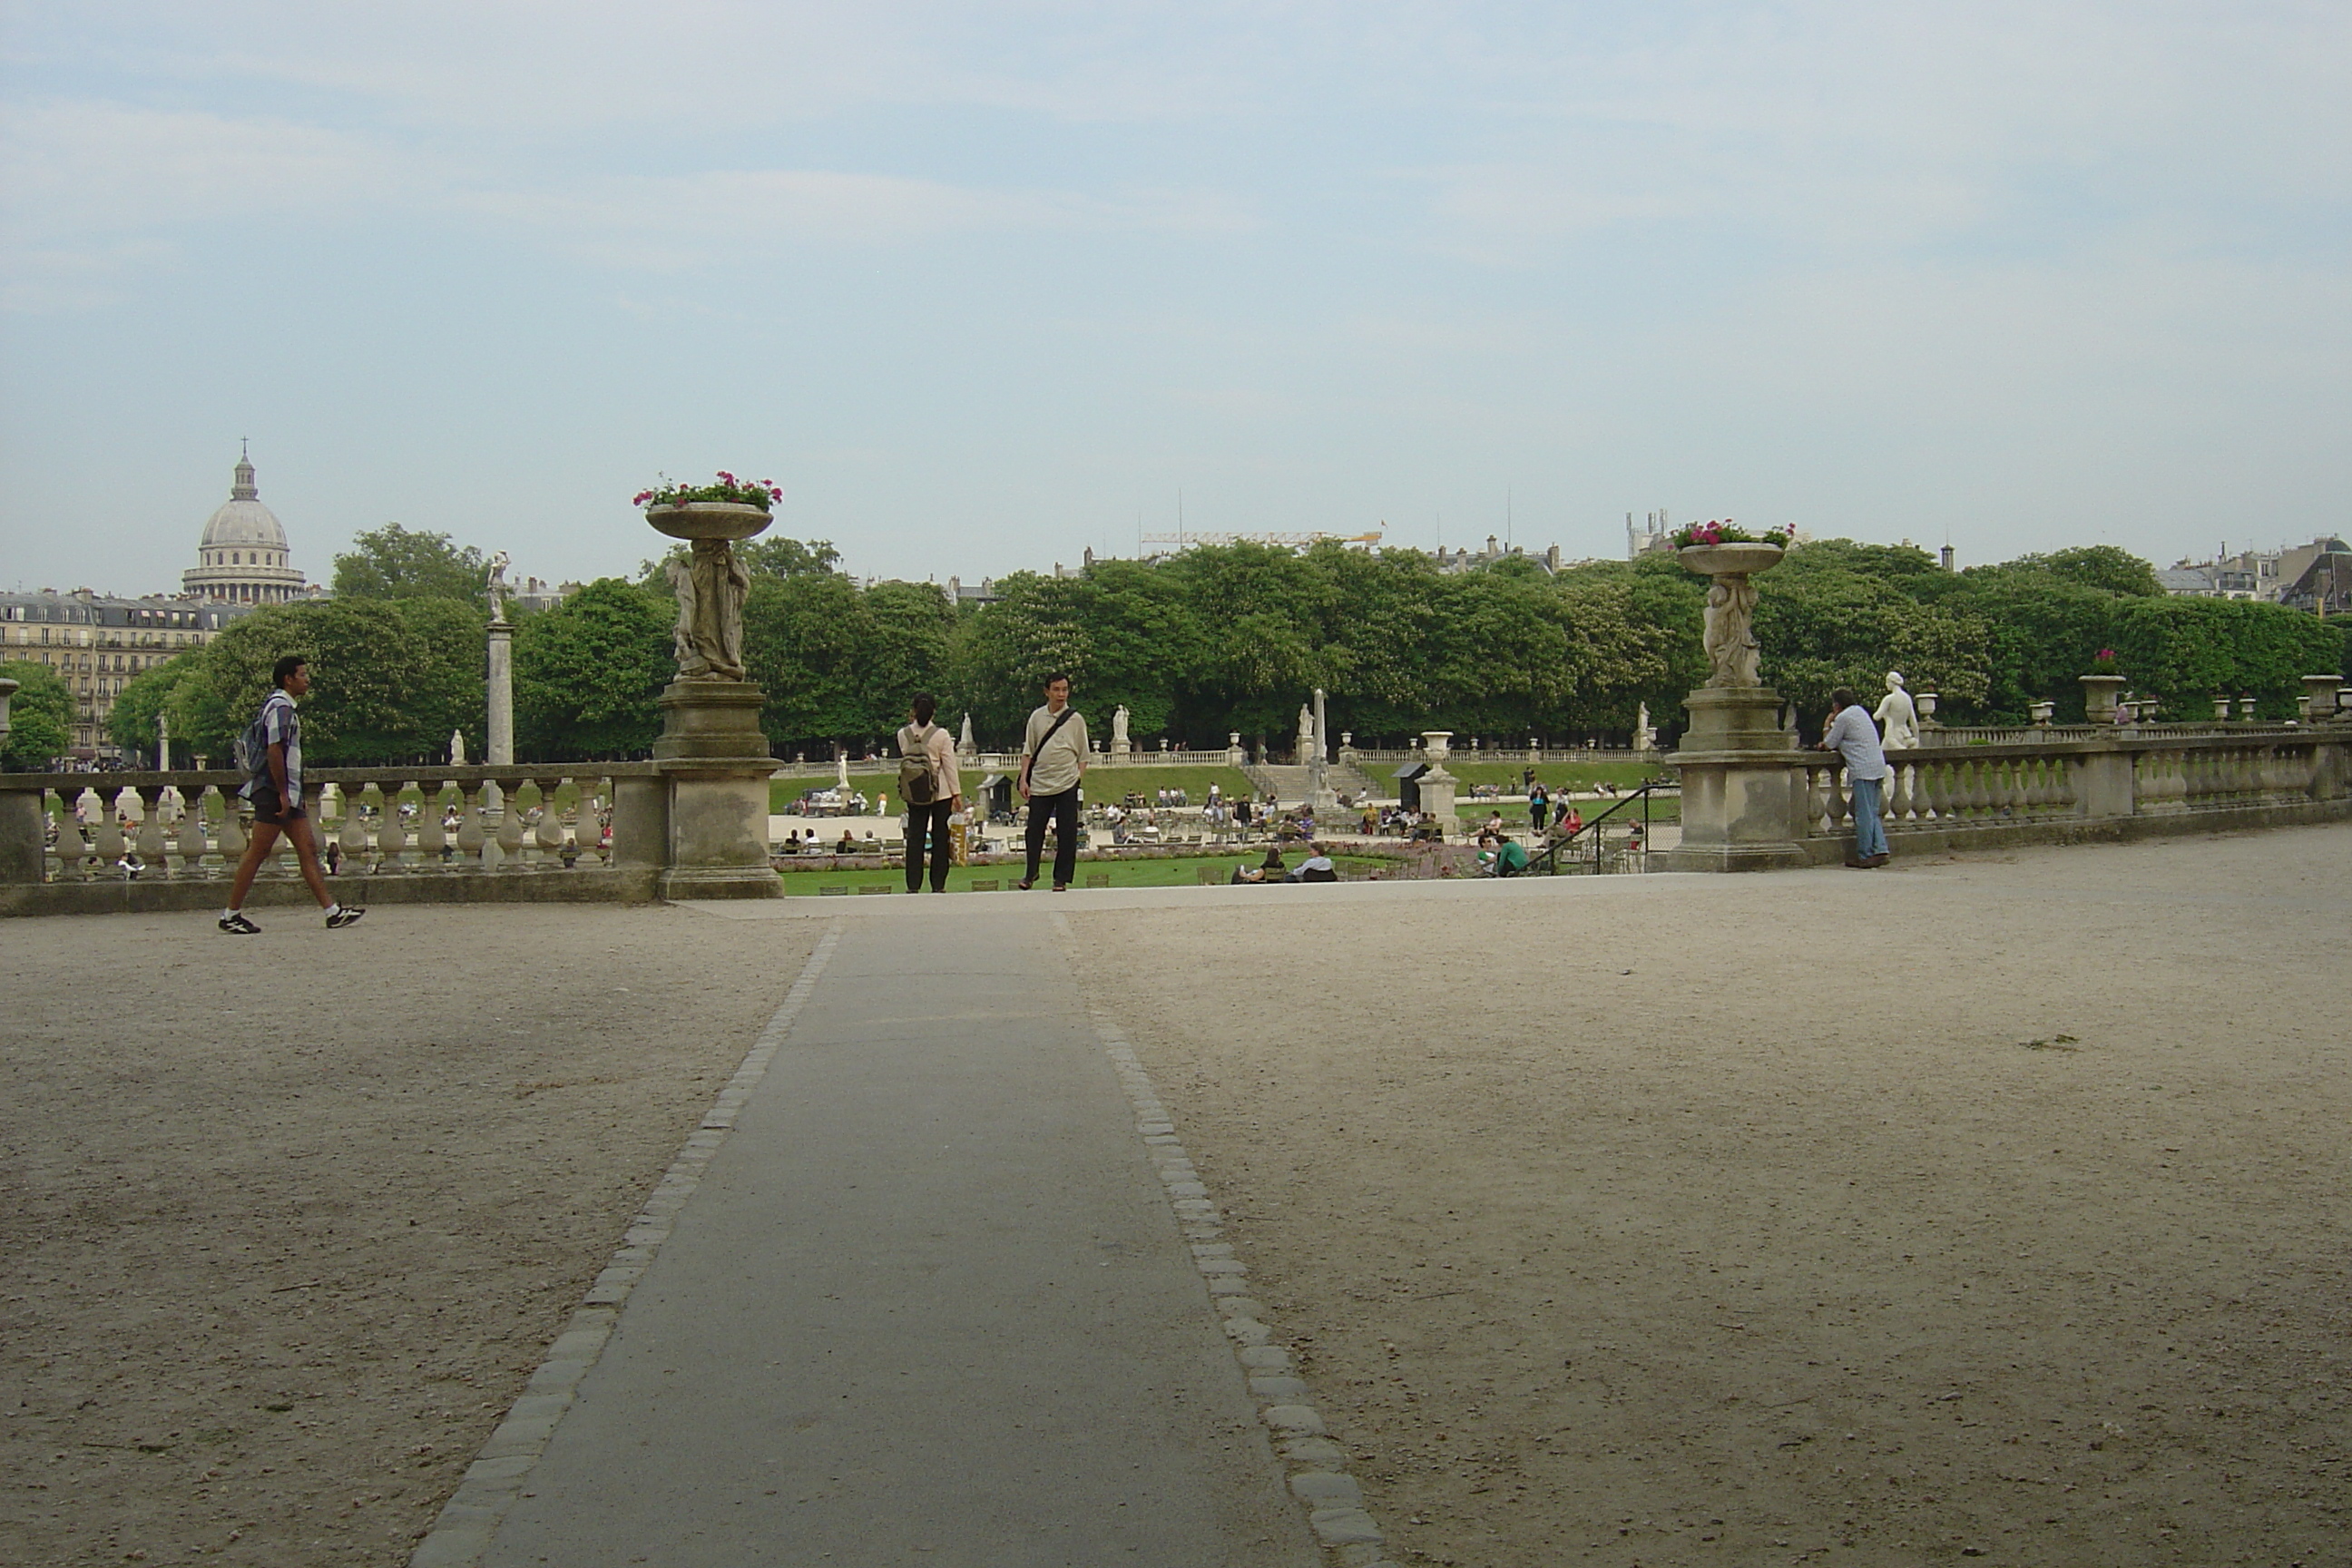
515, 578, 677, 761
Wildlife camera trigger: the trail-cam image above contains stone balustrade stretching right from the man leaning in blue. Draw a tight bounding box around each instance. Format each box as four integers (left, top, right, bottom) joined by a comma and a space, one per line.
1797, 724, 2352, 839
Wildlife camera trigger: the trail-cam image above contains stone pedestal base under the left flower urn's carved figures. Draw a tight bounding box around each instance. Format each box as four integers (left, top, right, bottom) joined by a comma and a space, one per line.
653, 680, 783, 898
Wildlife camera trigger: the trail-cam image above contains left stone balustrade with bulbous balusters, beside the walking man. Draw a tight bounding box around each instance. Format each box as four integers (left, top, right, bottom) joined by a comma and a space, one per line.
0, 764, 666, 910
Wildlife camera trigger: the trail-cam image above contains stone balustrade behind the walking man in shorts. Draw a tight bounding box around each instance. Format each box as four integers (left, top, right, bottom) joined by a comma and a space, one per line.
0, 761, 659, 882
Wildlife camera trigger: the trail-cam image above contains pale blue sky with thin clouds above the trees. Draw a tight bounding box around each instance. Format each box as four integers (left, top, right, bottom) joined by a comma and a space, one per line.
0, 0, 2352, 594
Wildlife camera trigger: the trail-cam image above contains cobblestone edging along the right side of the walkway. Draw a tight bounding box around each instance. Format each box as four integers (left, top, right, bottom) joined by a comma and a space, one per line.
1054, 915, 1397, 1568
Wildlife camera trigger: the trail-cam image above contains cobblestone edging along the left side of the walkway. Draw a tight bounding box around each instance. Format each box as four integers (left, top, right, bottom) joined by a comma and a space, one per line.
409, 922, 842, 1568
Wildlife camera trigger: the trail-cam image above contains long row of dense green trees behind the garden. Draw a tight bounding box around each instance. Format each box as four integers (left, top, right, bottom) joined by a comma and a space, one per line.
86, 526, 2347, 764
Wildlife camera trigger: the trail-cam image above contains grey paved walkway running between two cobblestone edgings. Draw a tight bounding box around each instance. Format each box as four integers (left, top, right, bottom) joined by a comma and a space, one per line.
482, 898, 1322, 1568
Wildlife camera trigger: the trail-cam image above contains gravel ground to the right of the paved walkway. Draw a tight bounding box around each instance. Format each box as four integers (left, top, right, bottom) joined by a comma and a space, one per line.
1070, 828, 2352, 1568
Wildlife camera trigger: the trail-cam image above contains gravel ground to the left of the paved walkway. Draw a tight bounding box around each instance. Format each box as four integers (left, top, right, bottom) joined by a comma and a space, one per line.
0, 907, 821, 1568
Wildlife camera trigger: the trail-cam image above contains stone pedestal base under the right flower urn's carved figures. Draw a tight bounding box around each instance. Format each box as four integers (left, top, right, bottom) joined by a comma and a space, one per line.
1649, 686, 1808, 872
